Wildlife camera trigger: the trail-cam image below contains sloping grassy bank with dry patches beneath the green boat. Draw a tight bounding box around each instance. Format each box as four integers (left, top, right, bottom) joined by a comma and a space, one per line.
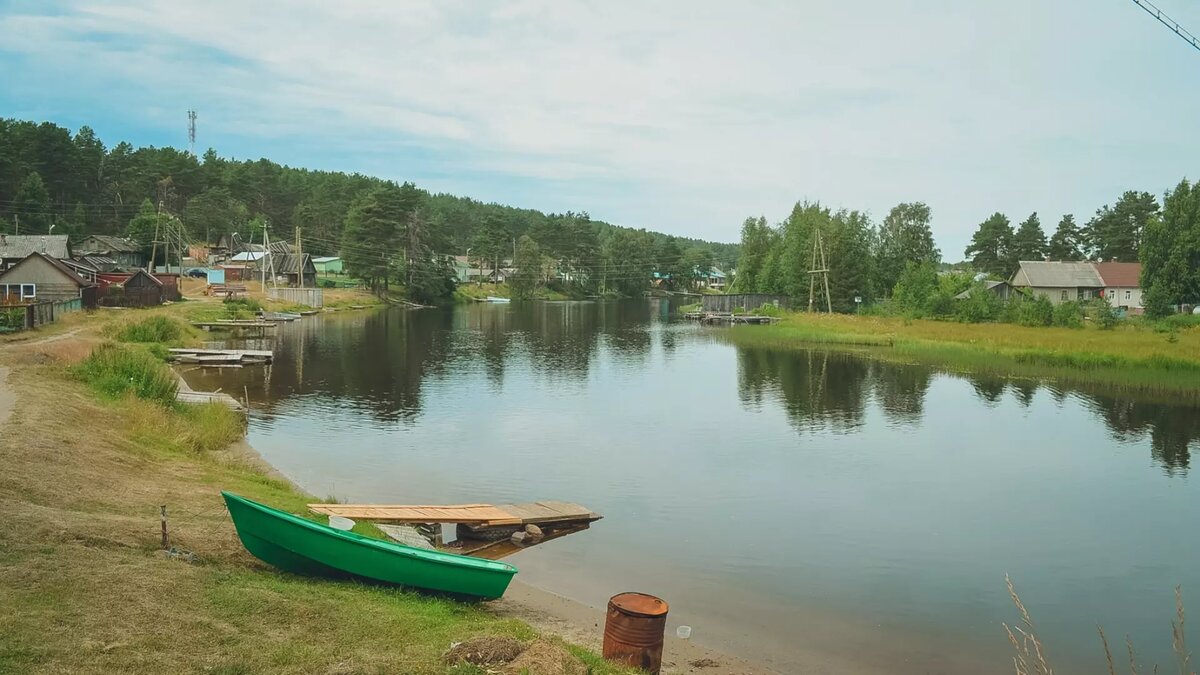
0, 319, 623, 675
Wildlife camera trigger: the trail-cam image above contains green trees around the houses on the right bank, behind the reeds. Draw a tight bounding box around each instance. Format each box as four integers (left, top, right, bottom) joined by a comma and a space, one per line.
733, 179, 1200, 324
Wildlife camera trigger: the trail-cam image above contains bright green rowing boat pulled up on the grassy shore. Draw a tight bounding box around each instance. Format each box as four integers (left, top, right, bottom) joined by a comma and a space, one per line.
221, 492, 517, 599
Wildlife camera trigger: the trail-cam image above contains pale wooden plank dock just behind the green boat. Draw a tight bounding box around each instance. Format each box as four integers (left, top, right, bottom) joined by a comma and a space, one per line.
308, 501, 602, 527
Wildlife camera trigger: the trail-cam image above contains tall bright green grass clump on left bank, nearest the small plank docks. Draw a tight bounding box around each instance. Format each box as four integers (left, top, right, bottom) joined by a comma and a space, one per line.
72, 342, 179, 406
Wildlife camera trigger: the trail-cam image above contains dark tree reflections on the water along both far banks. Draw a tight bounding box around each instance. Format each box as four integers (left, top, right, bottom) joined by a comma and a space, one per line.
187, 301, 1200, 473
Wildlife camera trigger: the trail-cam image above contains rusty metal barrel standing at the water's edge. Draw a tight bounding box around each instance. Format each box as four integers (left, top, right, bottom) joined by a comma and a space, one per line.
604, 593, 668, 675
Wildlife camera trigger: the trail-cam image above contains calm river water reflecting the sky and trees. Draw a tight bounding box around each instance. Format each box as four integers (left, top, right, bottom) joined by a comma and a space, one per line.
188, 301, 1200, 673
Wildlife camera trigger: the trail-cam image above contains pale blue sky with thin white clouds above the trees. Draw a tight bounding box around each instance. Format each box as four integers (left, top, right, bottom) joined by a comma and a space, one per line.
0, 0, 1200, 254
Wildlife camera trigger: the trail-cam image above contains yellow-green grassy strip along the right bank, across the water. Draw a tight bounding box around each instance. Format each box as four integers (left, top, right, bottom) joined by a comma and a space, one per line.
728, 313, 1200, 398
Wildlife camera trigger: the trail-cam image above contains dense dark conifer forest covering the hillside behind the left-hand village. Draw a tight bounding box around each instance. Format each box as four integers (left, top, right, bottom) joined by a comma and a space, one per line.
0, 119, 738, 298
